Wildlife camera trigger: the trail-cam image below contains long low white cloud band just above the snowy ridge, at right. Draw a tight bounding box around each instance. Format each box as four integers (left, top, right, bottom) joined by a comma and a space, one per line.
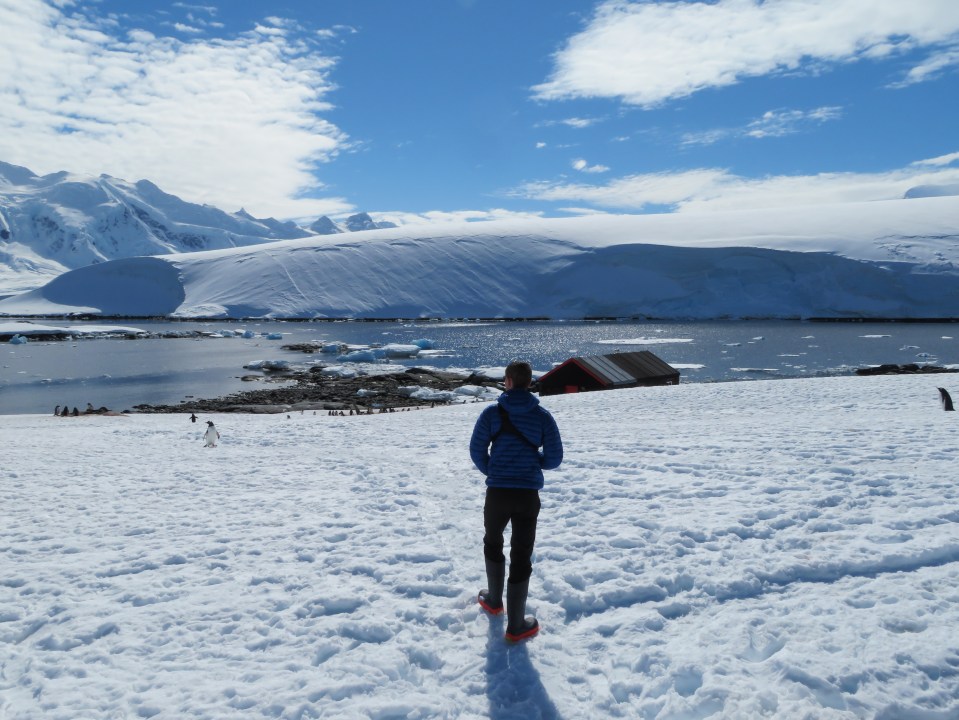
513, 153, 959, 211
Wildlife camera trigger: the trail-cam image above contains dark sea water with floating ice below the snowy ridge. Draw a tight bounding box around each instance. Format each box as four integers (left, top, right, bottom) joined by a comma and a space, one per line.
0, 321, 959, 414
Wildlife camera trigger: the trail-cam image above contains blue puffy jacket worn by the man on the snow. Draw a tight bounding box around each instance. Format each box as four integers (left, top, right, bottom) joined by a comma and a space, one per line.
470, 388, 563, 490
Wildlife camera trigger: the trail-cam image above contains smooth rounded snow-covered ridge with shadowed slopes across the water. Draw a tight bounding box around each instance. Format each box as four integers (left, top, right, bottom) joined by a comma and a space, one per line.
0, 196, 959, 319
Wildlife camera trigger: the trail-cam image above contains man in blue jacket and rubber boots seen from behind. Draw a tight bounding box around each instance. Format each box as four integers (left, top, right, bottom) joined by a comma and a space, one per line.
470, 361, 563, 642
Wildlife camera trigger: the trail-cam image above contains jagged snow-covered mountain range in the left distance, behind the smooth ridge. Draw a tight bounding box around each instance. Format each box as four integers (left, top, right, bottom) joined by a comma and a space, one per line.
0, 162, 390, 296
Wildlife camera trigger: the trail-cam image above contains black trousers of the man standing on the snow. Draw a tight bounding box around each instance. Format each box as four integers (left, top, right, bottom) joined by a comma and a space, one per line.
483, 488, 540, 582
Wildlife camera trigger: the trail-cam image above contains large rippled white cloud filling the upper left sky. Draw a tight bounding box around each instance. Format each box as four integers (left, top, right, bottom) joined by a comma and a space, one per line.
0, 0, 352, 217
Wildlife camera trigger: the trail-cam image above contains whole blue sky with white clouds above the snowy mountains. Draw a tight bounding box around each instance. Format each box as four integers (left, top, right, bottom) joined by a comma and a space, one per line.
0, 0, 959, 223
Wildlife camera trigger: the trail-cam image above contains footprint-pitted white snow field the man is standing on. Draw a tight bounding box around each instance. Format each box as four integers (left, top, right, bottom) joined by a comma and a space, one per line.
0, 375, 959, 720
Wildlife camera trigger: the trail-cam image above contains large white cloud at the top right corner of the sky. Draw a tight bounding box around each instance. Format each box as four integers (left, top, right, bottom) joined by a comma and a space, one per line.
533, 0, 959, 107
